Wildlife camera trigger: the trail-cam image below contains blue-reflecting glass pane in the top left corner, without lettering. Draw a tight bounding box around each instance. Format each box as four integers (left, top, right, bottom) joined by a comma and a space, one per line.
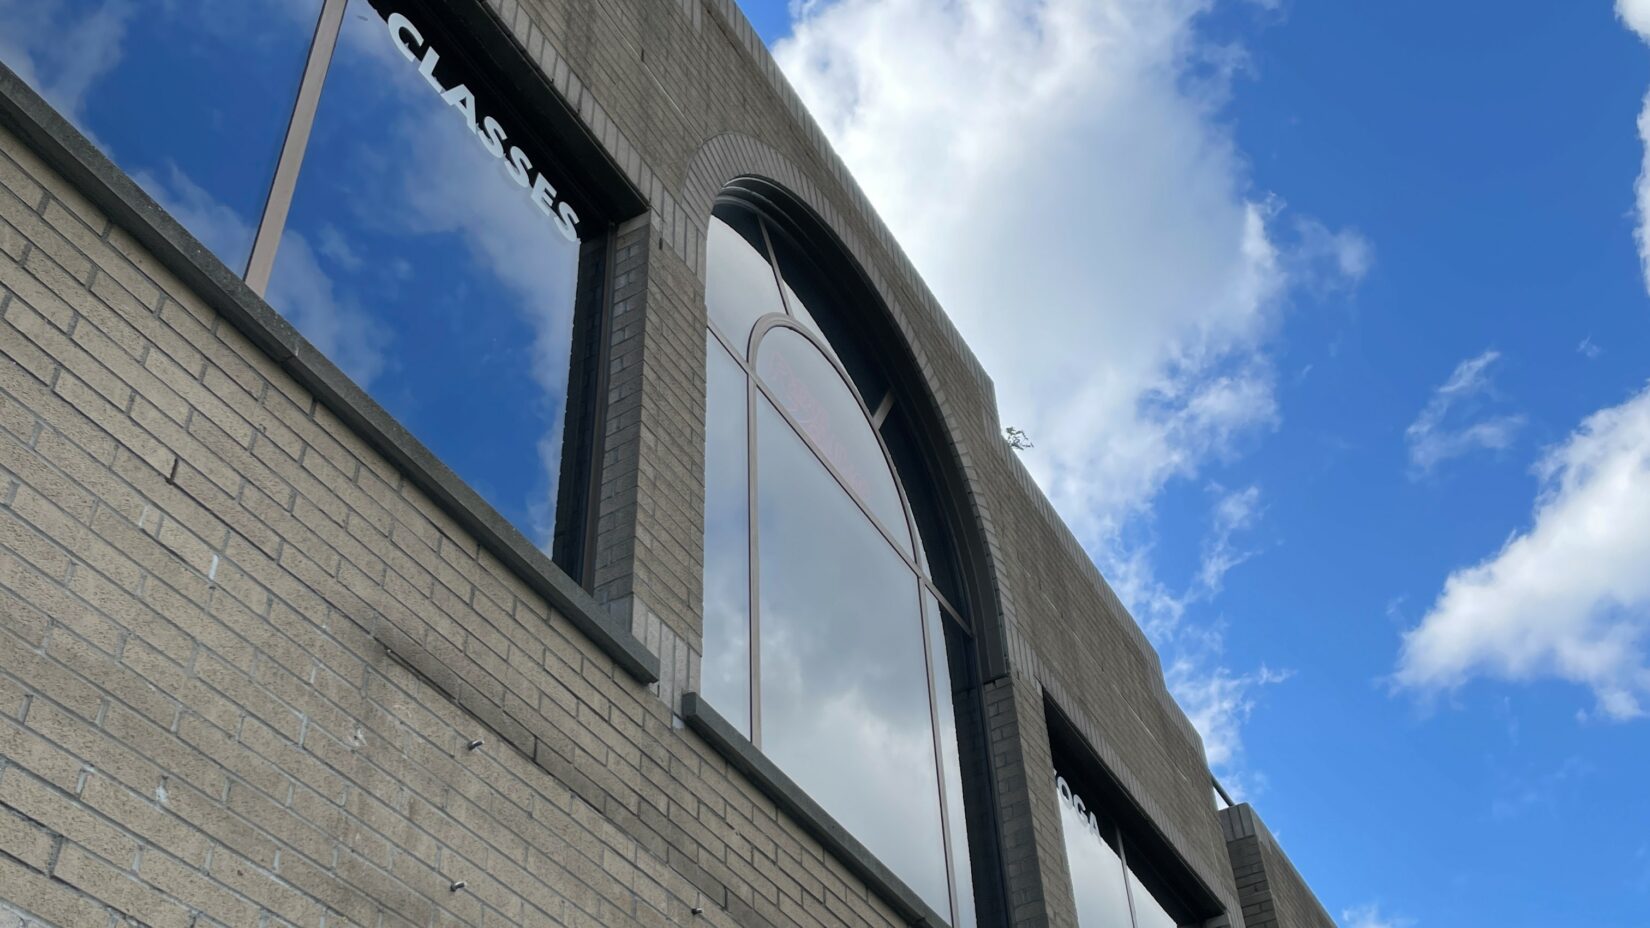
0, 0, 320, 272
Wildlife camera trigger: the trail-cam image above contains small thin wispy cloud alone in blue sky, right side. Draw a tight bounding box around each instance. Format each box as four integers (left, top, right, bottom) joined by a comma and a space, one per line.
1404, 348, 1525, 479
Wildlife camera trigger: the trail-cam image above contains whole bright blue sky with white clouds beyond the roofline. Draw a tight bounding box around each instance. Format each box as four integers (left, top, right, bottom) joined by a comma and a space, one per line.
755, 0, 1650, 928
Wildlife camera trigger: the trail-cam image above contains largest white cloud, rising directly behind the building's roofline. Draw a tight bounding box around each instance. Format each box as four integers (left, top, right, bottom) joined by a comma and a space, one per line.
774, 0, 1373, 779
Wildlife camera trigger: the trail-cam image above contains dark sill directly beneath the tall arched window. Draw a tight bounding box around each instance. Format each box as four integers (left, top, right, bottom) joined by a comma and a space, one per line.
681, 694, 949, 928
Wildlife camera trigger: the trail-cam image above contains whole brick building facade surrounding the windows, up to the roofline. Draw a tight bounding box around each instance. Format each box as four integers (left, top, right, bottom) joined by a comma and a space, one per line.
0, 0, 1333, 928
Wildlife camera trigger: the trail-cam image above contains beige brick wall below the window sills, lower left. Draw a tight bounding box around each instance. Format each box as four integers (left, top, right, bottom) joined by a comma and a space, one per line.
0, 123, 930, 928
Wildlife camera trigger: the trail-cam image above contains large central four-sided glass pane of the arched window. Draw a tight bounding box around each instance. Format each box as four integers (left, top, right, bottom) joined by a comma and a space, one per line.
756, 398, 950, 911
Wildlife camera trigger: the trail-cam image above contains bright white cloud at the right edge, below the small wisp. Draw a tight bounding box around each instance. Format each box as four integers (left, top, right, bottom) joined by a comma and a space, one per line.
1394, 379, 1650, 720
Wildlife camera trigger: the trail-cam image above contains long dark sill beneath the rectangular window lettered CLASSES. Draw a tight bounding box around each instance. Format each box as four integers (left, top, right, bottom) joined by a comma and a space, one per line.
0, 57, 658, 684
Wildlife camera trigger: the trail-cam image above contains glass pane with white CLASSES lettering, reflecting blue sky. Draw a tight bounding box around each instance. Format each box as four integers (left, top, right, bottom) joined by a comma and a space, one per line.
269, 0, 579, 547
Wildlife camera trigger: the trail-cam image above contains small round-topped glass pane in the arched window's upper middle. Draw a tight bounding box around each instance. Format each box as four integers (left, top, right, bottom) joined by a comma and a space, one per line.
756, 327, 911, 553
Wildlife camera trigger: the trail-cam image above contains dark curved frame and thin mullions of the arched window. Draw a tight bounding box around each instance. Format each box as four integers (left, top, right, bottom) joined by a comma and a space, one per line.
706, 177, 1008, 925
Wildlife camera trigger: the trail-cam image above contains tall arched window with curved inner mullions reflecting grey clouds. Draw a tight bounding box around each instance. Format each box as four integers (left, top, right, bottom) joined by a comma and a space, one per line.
700, 196, 977, 928
